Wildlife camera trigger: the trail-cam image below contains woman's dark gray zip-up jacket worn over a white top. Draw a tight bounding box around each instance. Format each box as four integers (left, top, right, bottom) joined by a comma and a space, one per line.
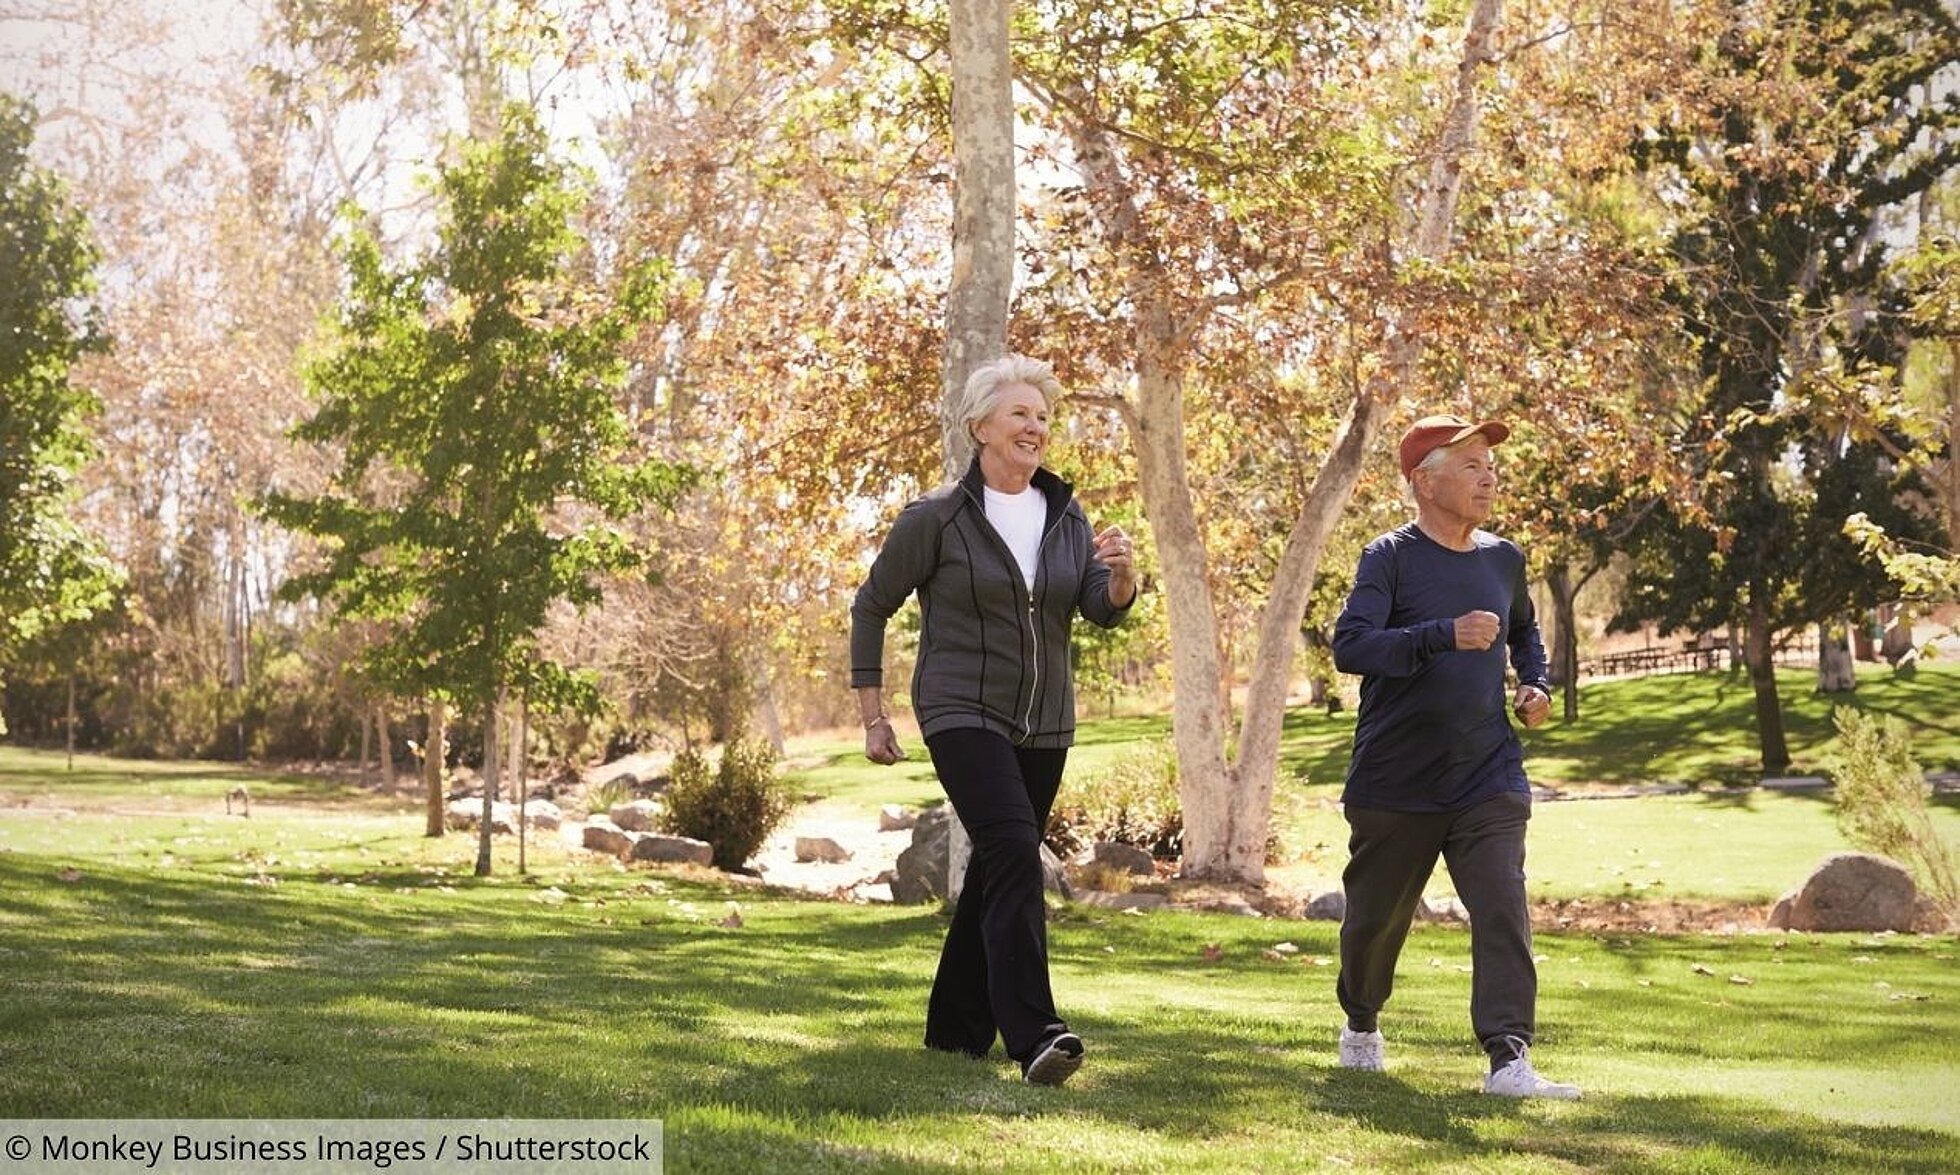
851, 461, 1129, 747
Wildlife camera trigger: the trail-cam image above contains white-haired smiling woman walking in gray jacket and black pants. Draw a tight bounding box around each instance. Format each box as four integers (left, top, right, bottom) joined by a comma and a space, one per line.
851, 355, 1137, 1085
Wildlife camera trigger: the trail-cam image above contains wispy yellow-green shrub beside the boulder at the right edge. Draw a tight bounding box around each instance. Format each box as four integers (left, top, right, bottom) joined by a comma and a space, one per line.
1833, 706, 1960, 924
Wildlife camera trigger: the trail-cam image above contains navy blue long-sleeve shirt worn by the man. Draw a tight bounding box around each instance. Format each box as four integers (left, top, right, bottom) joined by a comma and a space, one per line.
1335, 522, 1550, 812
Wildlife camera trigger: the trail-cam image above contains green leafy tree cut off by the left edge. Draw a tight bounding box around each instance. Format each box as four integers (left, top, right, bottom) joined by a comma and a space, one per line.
0, 92, 116, 717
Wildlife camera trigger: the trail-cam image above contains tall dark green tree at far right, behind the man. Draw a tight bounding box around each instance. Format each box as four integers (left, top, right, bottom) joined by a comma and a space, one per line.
1623, 0, 1960, 773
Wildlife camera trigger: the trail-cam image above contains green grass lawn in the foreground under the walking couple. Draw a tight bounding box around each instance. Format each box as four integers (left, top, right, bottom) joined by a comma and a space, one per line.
0, 751, 1960, 1171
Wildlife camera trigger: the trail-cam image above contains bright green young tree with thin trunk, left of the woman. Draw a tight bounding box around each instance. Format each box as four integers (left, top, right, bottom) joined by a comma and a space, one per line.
265, 106, 686, 875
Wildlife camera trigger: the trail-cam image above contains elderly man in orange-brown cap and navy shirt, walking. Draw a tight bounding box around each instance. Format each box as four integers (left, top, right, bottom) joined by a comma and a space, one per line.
1335, 416, 1580, 1098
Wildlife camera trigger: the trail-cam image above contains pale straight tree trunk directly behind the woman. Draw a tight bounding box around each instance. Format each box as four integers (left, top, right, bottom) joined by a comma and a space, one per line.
939, 0, 1015, 900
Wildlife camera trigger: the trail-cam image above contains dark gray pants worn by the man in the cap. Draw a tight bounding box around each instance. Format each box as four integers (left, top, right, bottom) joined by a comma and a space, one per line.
1335, 792, 1539, 1051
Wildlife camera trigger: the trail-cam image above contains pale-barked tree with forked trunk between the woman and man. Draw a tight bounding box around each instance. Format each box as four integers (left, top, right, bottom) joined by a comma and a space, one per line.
1023, 0, 1501, 883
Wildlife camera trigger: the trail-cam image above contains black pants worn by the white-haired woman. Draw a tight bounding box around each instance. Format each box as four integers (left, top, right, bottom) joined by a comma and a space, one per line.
925, 730, 1068, 1063
